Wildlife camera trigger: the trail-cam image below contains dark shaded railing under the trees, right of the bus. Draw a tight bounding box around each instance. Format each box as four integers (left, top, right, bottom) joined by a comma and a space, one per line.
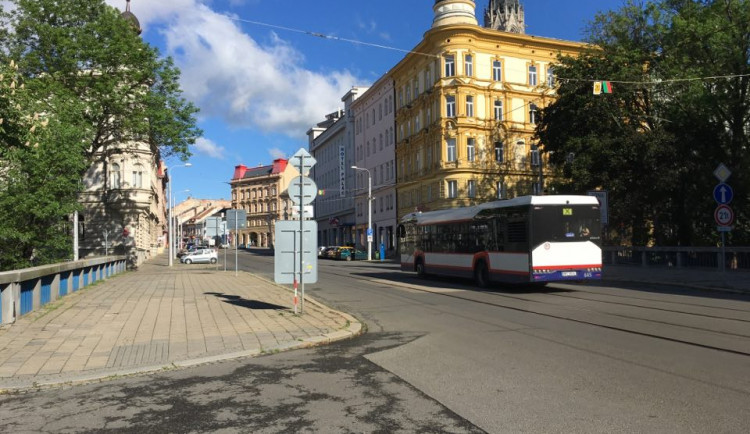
602, 246, 750, 271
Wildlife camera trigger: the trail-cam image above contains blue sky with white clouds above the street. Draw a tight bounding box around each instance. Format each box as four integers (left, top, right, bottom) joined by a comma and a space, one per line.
106, 0, 623, 202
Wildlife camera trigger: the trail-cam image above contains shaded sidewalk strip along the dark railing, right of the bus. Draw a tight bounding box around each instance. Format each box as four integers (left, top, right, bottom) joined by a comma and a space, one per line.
603, 265, 750, 294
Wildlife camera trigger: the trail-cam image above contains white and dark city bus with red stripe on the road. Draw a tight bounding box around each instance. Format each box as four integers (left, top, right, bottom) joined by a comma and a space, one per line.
398, 195, 602, 287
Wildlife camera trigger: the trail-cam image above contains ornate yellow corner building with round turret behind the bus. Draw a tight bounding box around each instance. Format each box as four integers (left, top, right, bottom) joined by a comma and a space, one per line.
389, 0, 585, 219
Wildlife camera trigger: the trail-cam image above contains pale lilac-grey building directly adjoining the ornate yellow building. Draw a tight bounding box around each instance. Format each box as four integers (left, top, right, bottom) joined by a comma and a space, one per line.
351, 74, 397, 257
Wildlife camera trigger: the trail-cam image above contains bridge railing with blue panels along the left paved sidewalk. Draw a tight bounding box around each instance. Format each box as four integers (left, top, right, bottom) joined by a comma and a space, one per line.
0, 256, 127, 324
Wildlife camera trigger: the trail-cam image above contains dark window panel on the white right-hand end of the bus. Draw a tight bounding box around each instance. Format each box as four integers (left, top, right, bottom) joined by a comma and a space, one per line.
531, 205, 601, 246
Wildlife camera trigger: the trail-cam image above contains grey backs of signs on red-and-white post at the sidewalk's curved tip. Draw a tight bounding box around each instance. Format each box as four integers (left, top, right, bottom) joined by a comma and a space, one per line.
274, 148, 318, 314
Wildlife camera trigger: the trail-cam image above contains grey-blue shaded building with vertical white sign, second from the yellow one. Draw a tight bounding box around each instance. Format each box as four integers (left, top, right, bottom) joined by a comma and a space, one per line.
307, 87, 367, 246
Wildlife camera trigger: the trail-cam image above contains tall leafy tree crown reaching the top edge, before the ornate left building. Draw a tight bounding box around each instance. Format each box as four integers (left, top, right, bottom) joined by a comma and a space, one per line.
2, 0, 201, 160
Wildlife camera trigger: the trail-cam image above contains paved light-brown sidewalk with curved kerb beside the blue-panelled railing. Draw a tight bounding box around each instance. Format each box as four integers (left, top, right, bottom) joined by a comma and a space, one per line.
0, 255, 362, 392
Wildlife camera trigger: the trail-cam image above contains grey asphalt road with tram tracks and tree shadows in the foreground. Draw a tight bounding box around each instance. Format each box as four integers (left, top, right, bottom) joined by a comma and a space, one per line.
0, 252, 750, 433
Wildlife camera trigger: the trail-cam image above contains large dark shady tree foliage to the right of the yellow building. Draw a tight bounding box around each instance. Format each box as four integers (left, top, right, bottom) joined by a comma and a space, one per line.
537, 0, 750, 245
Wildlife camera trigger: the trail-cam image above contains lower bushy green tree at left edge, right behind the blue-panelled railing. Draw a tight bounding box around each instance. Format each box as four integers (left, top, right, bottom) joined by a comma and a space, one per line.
0, 63, 90, 270
